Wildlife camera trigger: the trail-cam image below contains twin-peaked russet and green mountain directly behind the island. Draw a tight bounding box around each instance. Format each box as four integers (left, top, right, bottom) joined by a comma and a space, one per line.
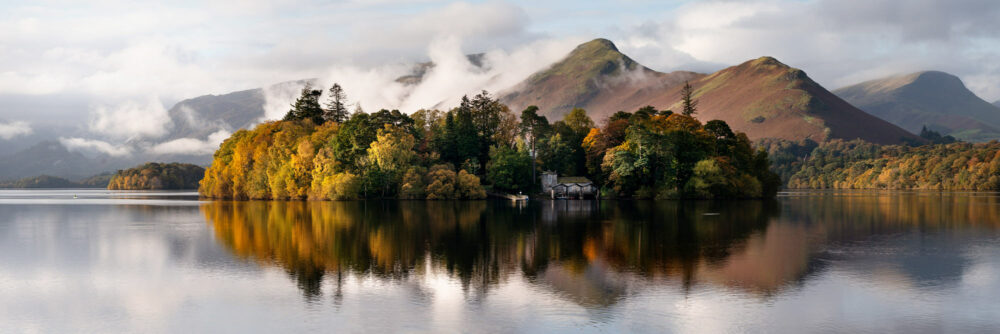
501, 39, 921, 143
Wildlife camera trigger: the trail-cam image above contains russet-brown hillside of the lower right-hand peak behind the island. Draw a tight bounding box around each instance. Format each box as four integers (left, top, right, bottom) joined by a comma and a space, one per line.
649, 57, 921, 144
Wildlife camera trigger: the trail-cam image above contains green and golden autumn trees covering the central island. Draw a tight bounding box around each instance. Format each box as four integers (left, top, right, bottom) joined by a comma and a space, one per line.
199, 84, 780, 200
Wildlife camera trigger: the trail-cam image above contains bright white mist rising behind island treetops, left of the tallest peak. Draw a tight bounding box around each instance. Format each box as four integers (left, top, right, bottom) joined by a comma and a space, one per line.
264, 36, 584, 120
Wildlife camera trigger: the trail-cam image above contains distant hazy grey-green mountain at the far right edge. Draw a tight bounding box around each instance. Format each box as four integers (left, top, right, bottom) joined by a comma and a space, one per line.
835, 71, 1000, 141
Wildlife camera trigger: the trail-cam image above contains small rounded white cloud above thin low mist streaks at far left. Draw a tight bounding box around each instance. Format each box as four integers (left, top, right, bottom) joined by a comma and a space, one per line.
90, 97, 171, 138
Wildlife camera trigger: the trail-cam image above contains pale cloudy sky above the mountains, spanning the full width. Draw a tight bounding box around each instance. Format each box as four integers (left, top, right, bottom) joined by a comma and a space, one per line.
0, 0, 1000, 155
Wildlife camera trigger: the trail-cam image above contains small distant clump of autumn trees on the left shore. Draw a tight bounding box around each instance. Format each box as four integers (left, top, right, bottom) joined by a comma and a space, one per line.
108, 162, 205, 190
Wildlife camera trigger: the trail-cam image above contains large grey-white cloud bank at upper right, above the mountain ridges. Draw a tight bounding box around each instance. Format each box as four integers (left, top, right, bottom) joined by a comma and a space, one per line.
618, 0, 1000, 99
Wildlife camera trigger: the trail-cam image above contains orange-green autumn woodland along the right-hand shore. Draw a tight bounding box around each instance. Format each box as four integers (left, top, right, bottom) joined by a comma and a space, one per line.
764, 140, 1000, 191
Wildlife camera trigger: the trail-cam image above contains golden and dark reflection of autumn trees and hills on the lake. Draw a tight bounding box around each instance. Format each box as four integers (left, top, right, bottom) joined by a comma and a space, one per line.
201, 196, 1000, 307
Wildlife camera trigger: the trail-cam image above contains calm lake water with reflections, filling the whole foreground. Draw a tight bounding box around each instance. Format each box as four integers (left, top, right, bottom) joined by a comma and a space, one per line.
0, 190, 1000, 333
